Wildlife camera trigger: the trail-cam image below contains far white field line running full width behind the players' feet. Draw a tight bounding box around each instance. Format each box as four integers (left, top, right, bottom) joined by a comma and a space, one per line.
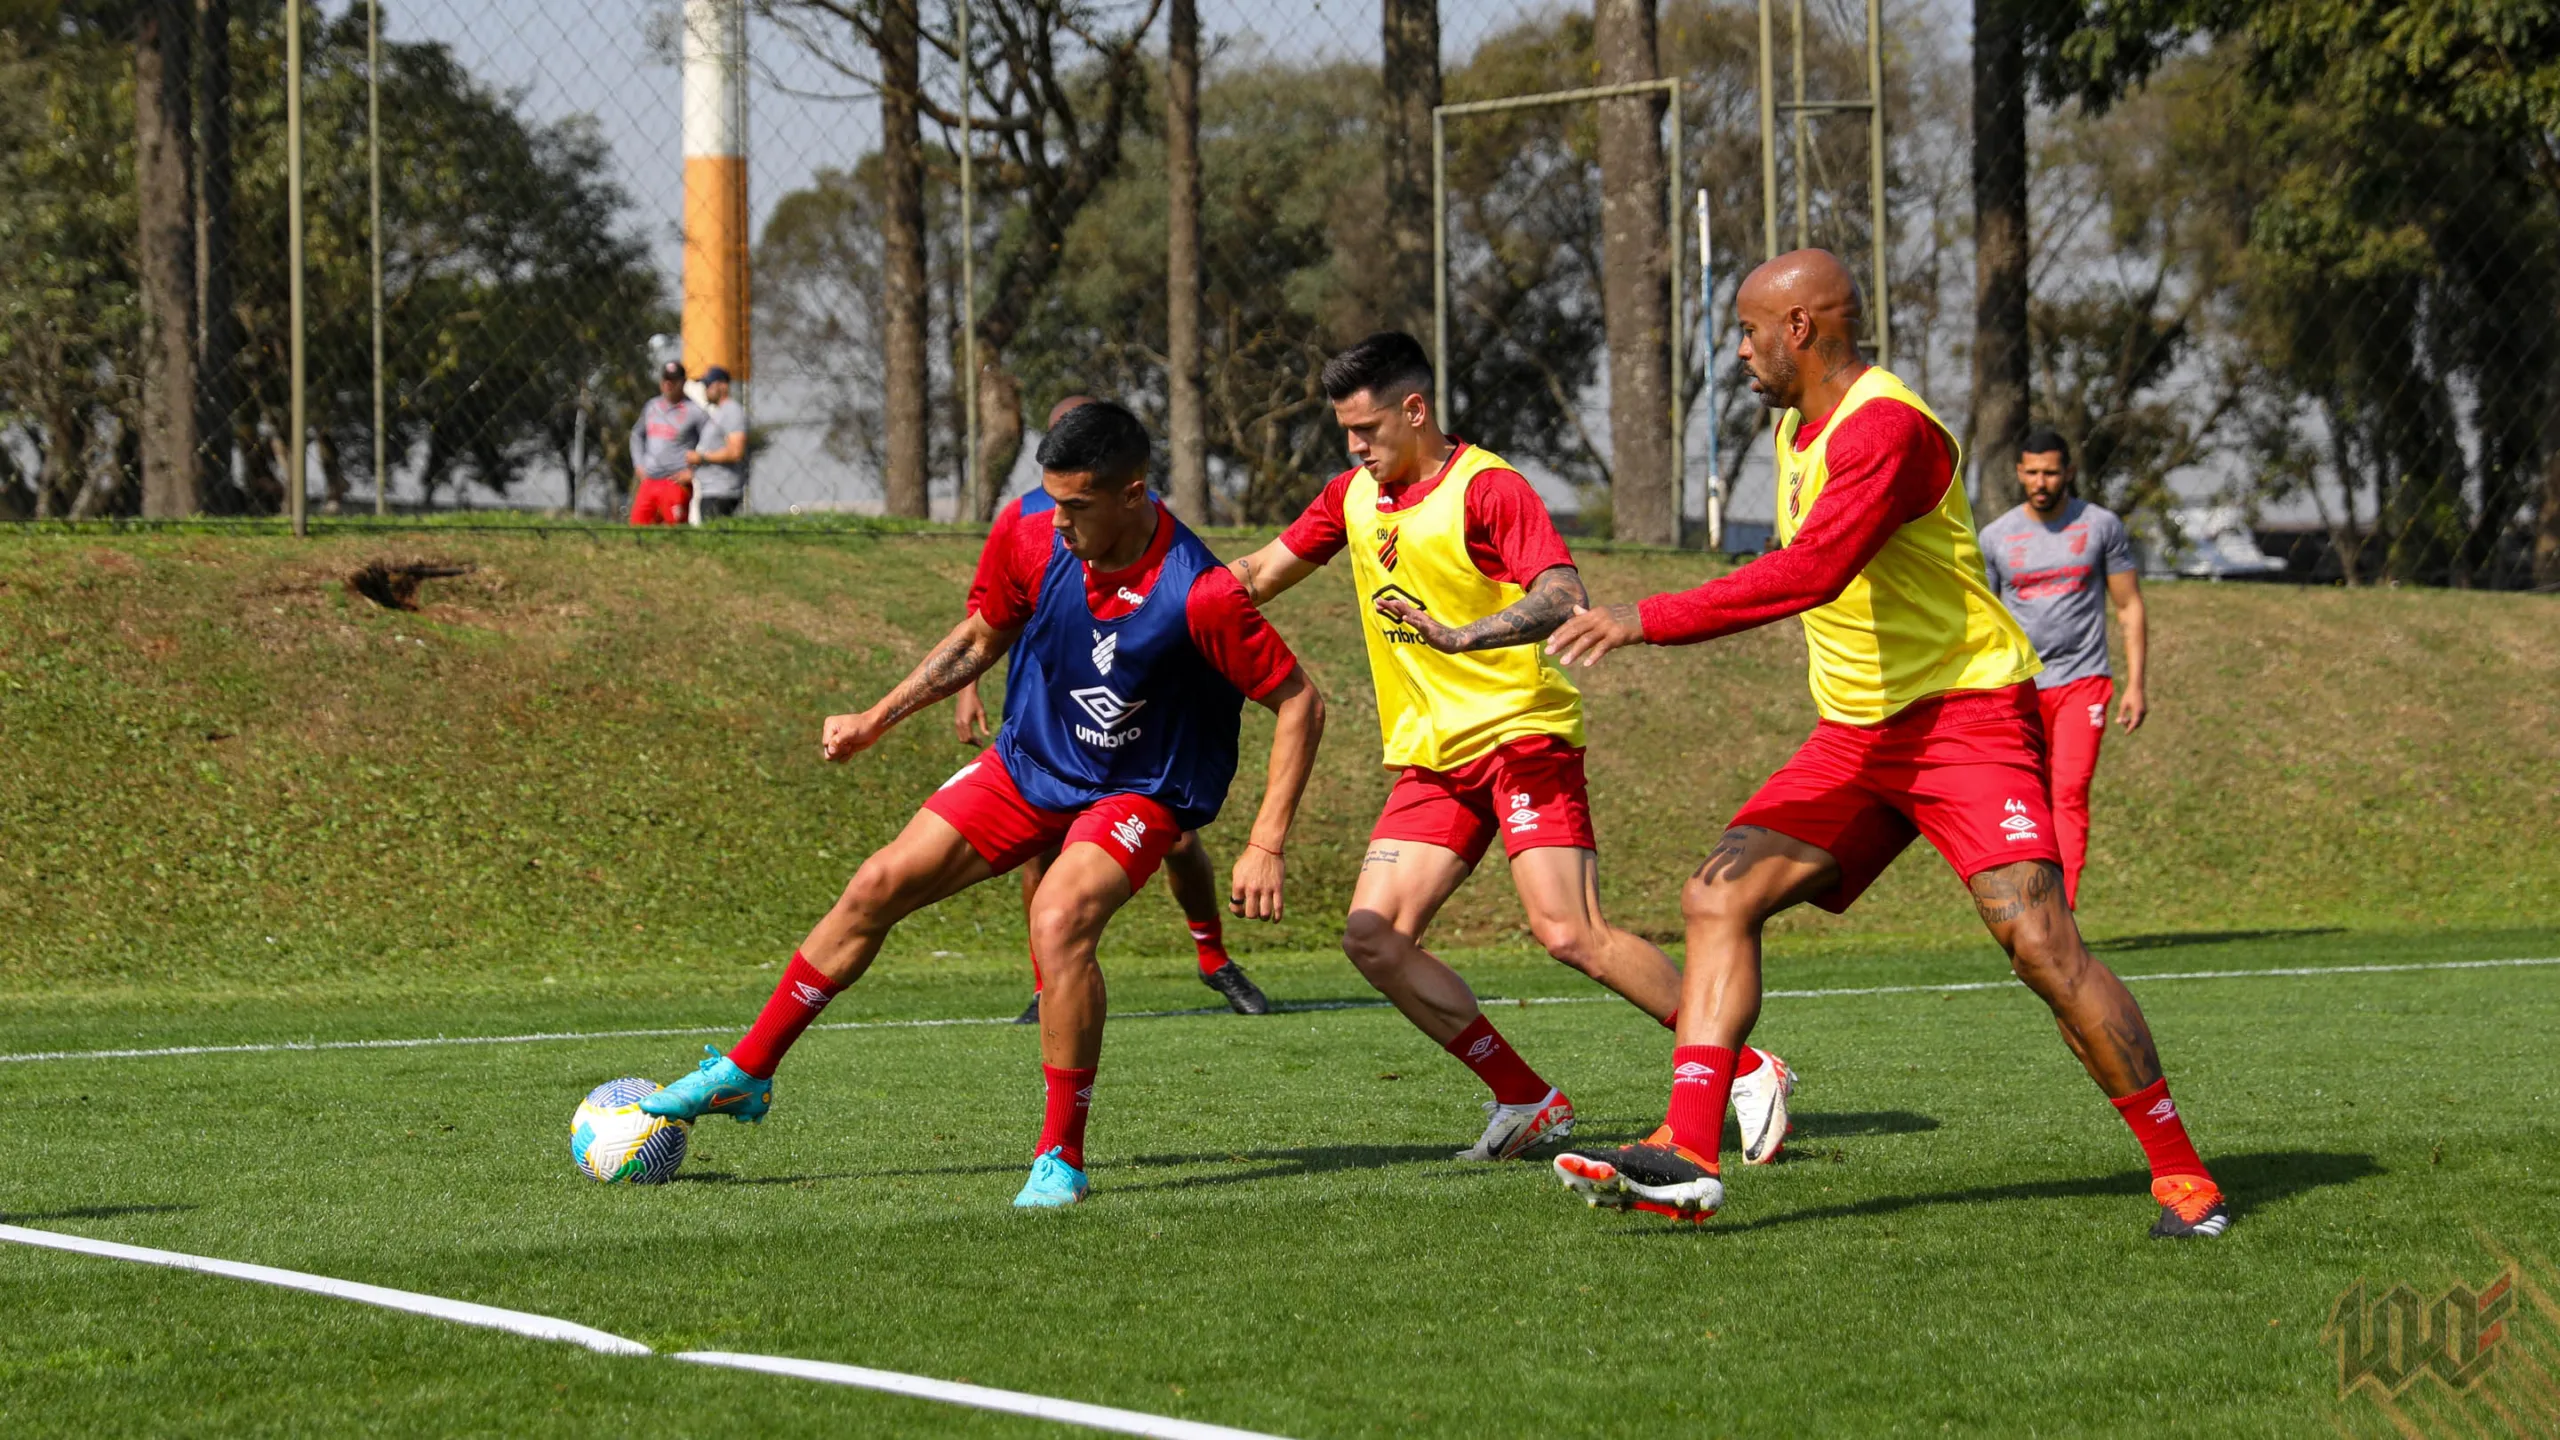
0, 956, 2560, 1063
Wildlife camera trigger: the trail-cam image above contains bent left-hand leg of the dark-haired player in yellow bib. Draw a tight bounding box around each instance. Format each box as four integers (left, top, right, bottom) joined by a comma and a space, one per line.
1341, 840, 1574, 1161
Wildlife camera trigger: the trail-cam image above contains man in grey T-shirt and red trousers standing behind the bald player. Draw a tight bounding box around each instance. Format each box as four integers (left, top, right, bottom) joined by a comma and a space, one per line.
1981, 430, 2150, 910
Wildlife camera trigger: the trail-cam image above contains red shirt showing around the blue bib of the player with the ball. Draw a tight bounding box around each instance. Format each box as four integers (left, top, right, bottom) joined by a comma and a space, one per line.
970, 500, 1298, 700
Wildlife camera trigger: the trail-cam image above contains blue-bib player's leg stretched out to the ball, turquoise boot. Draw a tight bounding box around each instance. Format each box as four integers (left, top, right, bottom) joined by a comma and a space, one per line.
640, 810, 993, 1120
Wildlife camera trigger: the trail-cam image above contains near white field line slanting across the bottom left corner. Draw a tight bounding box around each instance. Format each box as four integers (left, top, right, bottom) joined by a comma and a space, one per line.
0, 1225, 1300, 1440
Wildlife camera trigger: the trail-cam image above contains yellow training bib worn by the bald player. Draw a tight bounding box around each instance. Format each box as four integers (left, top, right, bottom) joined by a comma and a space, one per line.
1777, 369, 2045, 725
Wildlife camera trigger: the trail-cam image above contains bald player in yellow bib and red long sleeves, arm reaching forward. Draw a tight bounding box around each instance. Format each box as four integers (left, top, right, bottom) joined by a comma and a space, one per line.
1546, 251, 2230, 1238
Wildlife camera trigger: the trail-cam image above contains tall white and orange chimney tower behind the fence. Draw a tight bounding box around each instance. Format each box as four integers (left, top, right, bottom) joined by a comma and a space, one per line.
684, 0, 753, 382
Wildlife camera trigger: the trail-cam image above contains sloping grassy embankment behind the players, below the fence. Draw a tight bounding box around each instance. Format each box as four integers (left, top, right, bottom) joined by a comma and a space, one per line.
0, 533, 2560, 1038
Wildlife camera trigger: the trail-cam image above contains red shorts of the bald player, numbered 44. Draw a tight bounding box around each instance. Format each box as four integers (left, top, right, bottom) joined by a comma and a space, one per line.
1733, 682, 2061, 915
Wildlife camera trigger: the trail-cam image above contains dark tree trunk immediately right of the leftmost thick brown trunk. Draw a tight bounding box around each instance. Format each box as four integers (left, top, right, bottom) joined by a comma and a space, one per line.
195, 0, 241, 500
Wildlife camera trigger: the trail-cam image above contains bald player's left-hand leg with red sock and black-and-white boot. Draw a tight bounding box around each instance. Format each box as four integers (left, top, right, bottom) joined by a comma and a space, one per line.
1556, 828, 1841, 1220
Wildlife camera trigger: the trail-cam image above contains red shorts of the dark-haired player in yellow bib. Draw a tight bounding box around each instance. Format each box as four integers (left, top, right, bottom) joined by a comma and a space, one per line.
1370, 735, 1600, 866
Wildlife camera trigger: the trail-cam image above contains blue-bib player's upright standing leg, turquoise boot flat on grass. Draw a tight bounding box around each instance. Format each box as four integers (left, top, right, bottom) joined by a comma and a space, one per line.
1014, 840, 1132, 1209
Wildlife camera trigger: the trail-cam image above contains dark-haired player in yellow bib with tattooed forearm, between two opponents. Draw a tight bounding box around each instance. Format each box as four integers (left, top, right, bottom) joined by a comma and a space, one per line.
1234, 333, 1792, 1161
